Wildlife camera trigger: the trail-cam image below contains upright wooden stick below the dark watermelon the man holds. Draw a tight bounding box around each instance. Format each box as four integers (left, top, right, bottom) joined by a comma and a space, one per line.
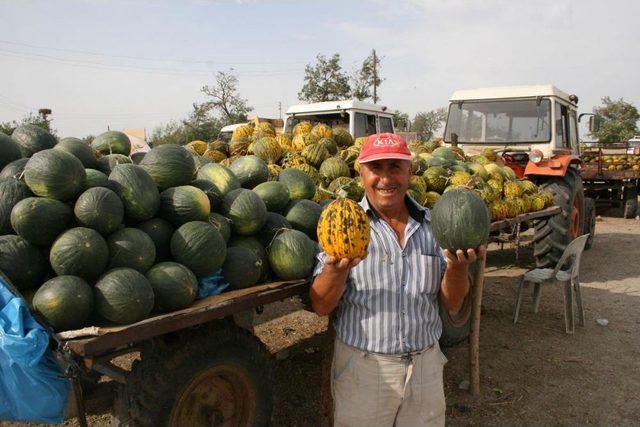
469, 256, 486, 396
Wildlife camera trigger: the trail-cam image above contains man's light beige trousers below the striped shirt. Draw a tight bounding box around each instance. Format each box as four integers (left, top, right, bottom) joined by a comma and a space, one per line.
331, 340, 447, 427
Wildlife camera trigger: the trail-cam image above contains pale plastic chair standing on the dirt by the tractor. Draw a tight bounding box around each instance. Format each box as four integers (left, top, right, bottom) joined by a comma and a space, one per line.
513, 234, 589, 334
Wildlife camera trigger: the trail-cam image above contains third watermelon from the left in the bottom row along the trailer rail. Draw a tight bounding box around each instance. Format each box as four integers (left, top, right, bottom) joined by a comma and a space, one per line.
146, 262, 198, 312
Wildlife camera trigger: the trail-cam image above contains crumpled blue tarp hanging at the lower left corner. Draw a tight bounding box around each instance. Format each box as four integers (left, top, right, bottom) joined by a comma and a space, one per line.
0, 277, 71, 423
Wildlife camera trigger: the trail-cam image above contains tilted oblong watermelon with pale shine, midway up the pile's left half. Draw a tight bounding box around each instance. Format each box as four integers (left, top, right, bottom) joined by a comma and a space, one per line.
109, 165, 160, 221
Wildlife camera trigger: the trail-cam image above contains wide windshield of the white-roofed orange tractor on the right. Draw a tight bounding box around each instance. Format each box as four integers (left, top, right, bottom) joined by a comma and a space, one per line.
445, 99, 551, 144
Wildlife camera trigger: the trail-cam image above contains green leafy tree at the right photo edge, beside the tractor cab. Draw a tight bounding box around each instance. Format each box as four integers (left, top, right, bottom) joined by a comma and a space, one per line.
592, 96, 640, 143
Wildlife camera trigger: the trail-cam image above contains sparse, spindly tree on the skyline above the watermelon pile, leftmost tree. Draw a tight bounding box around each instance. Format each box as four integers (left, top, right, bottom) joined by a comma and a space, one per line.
200, 71, 253, 125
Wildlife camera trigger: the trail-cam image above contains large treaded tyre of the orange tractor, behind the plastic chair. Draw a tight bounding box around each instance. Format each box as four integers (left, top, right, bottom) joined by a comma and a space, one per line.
533, 167, 584, 268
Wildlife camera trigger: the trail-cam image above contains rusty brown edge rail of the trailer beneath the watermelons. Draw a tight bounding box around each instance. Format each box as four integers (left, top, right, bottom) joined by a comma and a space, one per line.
65, 280, 309, 357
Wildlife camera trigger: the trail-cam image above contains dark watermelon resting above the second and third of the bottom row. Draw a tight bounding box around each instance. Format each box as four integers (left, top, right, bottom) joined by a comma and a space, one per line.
107, 228, 156, 274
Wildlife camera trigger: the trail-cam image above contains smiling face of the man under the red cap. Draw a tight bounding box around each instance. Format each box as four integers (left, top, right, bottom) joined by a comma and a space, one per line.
360, 159, 411, 210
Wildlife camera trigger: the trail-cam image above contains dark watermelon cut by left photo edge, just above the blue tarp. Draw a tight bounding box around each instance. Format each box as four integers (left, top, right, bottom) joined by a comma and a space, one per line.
0, 234, 47, 290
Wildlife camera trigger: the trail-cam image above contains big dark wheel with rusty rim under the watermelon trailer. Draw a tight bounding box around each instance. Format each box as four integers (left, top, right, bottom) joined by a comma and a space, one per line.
114, 322, 273, 426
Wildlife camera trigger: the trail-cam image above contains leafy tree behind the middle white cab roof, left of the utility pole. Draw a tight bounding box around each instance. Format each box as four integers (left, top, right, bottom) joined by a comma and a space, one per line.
298, 53, 351, 102
